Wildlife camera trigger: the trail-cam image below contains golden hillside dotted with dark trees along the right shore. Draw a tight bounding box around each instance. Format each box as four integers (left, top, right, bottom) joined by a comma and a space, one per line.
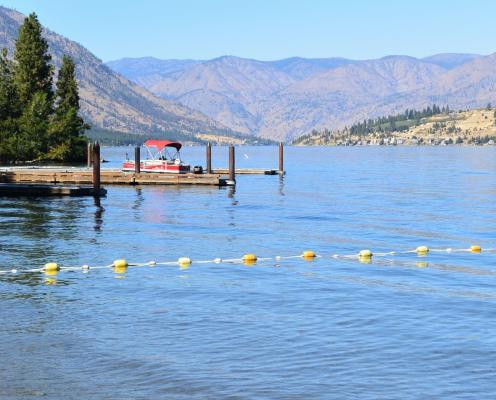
293, 108, 496, 146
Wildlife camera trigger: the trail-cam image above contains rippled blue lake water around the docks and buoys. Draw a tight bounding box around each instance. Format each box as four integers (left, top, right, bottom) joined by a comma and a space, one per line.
0, 147, 496, 400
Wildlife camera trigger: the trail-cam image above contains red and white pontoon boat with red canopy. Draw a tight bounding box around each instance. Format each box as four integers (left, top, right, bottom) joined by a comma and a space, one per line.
122, 140, 191, 174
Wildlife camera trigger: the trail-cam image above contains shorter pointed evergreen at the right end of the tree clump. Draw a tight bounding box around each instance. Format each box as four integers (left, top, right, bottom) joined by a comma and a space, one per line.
47, 56, 89, 161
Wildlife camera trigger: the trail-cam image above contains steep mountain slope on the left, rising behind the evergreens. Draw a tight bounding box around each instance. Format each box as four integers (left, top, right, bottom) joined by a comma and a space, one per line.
0, 6, 240, 142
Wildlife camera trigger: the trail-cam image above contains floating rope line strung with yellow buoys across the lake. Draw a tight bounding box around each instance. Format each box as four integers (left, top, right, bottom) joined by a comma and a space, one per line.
0, 245, 496, 275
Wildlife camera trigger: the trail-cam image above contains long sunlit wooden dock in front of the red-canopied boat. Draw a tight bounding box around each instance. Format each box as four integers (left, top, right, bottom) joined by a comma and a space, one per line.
0, 168, 227, 186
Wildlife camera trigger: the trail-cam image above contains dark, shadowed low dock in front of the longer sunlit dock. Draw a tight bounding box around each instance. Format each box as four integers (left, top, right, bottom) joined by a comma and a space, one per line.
0, 183, 107, 197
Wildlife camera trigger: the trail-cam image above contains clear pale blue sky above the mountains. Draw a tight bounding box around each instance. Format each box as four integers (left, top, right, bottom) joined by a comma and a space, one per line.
0, 0, 496, 61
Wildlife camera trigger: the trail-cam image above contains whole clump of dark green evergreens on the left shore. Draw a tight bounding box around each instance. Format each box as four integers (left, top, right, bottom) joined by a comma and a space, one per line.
0, 14, 89, 162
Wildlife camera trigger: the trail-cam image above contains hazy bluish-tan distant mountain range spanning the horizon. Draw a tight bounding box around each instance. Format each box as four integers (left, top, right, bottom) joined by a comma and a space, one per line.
104, 53, 496, 141
